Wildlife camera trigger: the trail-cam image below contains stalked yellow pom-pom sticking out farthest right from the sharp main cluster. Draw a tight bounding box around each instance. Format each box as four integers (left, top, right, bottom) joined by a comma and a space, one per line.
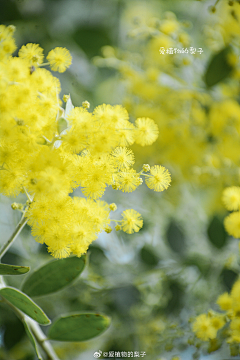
145, 165, 171, 191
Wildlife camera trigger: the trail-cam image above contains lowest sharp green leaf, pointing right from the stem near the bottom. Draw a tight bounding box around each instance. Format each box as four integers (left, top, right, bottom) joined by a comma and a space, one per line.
48, 313, 110, 341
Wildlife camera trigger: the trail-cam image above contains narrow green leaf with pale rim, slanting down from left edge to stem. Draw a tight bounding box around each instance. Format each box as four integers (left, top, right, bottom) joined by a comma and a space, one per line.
0, 287, 51, 325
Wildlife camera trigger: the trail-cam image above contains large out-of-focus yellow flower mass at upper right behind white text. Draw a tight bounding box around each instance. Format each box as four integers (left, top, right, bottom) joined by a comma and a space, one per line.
95, 1, 240, 211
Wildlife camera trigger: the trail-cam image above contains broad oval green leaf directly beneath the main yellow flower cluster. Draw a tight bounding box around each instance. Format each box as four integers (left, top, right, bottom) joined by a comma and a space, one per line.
22, 256, 86, 296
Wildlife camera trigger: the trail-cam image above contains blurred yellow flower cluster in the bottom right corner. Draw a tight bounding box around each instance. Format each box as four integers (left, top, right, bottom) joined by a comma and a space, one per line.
193, 279, 240, 344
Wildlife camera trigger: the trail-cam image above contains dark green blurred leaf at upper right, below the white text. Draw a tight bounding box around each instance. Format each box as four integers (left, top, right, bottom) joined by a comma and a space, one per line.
204, 46, 233, 87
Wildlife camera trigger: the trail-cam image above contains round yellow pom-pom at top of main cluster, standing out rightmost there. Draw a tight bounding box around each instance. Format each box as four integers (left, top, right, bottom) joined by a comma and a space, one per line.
47, 47, 72, 72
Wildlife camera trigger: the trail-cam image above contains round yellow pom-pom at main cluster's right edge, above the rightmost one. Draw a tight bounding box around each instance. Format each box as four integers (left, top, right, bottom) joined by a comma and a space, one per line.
135, 118, 159, 146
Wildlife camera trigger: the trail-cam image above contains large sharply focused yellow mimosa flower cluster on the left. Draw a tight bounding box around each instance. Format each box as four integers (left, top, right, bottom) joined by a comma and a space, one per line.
0, 25, 171, 258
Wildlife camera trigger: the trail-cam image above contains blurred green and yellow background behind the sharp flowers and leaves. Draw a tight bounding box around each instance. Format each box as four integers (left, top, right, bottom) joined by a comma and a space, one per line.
0, 0, 240, 360
